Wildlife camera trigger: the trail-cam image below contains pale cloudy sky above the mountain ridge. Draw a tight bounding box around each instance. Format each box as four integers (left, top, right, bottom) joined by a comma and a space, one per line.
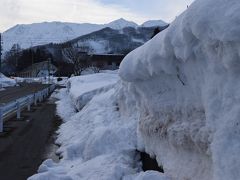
0, 0, 194, 32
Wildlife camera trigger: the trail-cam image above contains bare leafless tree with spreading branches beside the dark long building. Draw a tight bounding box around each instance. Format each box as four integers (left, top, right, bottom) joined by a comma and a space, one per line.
62, 45, 90, 76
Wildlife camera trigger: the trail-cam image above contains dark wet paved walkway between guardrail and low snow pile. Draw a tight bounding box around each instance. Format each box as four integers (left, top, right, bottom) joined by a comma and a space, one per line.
0, 97, 60, 180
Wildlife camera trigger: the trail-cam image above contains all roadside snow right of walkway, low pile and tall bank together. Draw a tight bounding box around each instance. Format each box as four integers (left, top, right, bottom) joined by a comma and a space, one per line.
30, 0, 240, 180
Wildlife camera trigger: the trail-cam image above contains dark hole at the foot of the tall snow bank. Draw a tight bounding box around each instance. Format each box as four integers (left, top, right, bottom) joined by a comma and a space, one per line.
138, 151, 164, 173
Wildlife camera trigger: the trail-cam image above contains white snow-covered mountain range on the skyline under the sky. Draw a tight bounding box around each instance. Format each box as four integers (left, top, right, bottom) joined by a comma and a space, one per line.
2, 18, 167, 52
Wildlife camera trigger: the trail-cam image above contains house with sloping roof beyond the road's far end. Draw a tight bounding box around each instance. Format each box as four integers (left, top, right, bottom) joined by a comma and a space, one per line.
17, 61, 57, 77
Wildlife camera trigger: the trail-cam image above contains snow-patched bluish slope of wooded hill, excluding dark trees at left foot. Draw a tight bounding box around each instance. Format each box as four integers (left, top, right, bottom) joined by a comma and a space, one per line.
39, 27, 165, 61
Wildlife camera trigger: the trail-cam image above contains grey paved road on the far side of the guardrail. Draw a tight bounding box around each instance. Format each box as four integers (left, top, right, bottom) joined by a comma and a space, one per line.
0, 83, 49, 104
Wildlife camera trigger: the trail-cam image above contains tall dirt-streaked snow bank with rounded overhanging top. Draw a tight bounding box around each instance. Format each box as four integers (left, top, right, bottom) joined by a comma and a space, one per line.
119, 0, 240, 180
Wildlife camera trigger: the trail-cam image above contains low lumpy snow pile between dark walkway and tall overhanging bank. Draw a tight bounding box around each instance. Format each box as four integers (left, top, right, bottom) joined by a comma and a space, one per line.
29, 73, 169, 180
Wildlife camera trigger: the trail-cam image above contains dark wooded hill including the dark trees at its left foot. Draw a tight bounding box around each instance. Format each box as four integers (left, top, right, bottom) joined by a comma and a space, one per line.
3, 26, 170, 75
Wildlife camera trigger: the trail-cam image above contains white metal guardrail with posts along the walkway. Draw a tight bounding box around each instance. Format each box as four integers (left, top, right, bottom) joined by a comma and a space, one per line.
0, 84, 56, 132
